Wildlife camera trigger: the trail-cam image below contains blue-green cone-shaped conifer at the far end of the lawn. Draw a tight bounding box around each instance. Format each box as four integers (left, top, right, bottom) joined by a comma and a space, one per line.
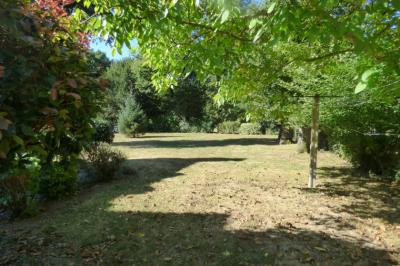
118, 97, 147, 137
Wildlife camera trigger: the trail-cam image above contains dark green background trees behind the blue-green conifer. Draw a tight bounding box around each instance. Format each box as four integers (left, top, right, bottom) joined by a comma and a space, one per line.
102, 58, 244, 132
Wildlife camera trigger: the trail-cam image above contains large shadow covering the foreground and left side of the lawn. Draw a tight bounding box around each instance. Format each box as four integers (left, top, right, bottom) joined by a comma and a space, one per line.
0, 158, 396, 265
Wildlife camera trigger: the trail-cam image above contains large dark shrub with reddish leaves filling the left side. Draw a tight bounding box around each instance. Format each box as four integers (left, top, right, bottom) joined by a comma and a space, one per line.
0, 1, 103, 179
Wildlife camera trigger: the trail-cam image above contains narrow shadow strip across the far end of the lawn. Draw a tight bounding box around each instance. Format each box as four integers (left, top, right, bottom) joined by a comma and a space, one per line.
113, 138, 278, 148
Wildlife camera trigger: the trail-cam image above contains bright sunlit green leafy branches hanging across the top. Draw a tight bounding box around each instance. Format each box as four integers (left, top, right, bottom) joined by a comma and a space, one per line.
76, 0, 400, 95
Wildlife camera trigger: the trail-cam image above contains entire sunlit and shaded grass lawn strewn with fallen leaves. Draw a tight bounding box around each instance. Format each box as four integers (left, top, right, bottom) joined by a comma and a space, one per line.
0, 133, 400, 265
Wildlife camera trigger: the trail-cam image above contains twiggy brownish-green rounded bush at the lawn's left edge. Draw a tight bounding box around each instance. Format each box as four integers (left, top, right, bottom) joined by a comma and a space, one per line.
84, 143, 126, 181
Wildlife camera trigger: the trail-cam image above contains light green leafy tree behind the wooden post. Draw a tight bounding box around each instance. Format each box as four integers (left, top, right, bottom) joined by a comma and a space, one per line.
243, 55, 400, 175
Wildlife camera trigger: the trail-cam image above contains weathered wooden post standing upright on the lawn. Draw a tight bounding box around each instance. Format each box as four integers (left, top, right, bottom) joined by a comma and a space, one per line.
308, 95, 319, 188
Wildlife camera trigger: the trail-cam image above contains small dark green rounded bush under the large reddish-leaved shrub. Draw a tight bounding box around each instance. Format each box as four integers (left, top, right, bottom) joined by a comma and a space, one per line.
38, 162, 78, 199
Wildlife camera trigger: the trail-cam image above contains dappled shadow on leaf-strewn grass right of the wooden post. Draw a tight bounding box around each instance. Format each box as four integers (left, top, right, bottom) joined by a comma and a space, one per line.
304, 167, 400, 225
